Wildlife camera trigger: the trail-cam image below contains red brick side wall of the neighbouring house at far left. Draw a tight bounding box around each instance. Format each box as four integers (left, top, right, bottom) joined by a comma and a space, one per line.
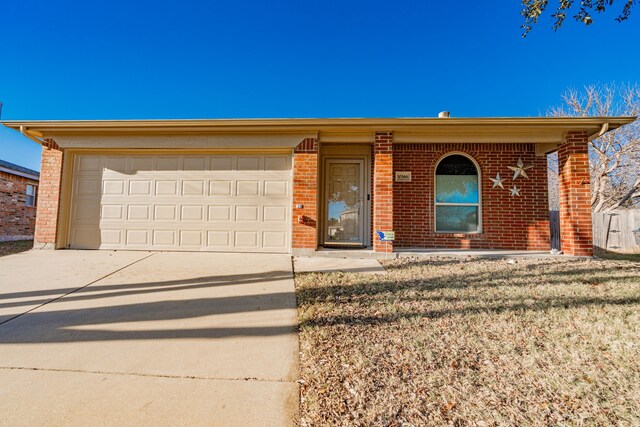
0, 172, 38, 241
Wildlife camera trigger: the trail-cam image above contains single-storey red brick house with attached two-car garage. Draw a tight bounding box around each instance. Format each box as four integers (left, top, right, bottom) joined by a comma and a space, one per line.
4, 117, 634, 255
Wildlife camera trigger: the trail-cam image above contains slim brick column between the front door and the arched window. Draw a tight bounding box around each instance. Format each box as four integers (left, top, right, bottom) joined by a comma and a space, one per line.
373, 132, 393, 252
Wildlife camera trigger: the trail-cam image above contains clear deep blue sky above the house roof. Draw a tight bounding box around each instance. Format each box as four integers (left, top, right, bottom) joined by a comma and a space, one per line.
0, 0, 640, 169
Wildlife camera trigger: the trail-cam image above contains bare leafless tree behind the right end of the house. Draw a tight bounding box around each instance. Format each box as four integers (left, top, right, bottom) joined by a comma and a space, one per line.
549, 83, 640, 212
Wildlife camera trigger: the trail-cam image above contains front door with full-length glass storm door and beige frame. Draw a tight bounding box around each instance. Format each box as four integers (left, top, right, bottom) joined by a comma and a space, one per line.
324, 159, 365, 246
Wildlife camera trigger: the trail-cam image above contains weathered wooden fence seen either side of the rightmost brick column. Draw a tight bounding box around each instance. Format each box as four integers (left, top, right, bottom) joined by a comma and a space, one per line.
549, 209, 640, 254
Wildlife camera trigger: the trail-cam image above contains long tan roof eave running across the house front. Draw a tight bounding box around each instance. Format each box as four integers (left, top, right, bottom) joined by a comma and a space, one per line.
0, 117, 636, 143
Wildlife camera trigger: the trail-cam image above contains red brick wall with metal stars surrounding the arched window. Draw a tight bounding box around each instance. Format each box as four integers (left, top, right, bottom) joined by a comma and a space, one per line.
393, 143, 550, 250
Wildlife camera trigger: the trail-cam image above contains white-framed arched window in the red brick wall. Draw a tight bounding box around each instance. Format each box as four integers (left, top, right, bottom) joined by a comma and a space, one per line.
436, 154, 480, 233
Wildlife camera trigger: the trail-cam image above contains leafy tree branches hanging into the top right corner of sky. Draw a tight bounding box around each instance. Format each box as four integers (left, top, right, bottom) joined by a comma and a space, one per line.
520, 0, 636, 37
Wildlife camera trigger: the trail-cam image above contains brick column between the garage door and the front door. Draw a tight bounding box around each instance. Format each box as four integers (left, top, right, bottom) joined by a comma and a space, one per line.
292, 138, 319, 255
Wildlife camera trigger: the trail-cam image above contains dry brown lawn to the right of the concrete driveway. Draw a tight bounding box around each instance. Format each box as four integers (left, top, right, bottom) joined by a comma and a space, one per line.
296, 258, 640, 426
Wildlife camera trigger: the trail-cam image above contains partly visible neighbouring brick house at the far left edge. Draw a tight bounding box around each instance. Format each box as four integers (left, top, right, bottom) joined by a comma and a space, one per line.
0, 160, 40, 242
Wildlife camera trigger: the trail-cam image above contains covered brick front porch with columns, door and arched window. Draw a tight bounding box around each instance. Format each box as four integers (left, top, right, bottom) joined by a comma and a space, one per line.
292, 130, 593, 258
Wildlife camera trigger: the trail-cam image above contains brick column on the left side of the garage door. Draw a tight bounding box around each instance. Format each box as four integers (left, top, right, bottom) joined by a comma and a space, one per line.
33, 139, 63, 249
